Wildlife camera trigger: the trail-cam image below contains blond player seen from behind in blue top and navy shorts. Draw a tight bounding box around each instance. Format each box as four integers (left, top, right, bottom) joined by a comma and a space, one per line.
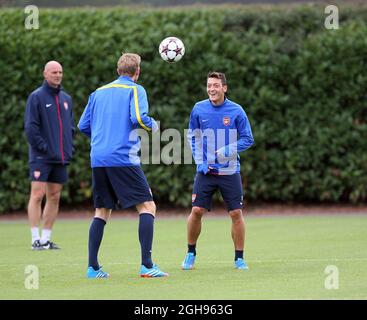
78, 53, 168, 278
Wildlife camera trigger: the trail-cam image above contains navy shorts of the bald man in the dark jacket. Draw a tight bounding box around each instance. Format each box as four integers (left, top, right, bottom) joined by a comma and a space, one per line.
29, 162, 68, 184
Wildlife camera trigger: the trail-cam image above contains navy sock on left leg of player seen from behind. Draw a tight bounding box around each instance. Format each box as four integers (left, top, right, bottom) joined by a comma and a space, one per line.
88, 218, 106, 270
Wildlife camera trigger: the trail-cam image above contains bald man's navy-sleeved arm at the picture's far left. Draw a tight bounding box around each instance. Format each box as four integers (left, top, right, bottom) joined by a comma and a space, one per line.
24, 94, 47, 153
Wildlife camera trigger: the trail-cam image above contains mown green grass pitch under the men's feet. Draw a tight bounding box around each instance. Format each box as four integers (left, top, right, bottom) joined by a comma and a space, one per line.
0, 215, 367, 300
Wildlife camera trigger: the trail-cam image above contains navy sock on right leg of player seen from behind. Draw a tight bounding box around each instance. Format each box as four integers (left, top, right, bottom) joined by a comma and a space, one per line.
139, 213, 154, 269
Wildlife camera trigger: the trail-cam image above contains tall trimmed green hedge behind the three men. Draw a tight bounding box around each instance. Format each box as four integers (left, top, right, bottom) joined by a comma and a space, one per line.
0, 5, 367, 212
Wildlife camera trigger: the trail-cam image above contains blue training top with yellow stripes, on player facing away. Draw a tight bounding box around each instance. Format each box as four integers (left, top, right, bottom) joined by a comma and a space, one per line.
78, 76, 158, 167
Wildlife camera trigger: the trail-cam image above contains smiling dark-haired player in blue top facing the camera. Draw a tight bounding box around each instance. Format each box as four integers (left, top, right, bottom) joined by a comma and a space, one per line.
181, 72, 254, 270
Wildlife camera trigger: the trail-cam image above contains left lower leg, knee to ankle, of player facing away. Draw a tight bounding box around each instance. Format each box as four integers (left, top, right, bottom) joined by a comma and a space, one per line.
88, 208, 112, 271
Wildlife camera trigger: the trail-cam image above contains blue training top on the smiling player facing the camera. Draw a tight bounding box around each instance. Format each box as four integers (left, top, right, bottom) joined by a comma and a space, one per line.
187, 98, 254, 175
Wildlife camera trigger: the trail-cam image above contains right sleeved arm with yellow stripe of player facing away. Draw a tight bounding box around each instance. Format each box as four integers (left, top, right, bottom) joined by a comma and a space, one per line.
130, 86, 158, 132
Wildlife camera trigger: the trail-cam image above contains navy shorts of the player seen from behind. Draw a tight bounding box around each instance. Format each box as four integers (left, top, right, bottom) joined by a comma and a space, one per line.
92, 166, 153, 209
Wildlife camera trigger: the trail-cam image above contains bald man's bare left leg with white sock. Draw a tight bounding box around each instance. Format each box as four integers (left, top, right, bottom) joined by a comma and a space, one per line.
28, 181, 46, 244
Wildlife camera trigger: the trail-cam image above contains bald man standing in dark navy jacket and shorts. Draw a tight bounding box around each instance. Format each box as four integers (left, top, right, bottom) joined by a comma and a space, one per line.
24, 61, 75, 250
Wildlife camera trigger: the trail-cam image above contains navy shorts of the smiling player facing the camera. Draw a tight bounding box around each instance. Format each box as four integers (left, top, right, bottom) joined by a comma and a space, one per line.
192, 173, 243, 211
